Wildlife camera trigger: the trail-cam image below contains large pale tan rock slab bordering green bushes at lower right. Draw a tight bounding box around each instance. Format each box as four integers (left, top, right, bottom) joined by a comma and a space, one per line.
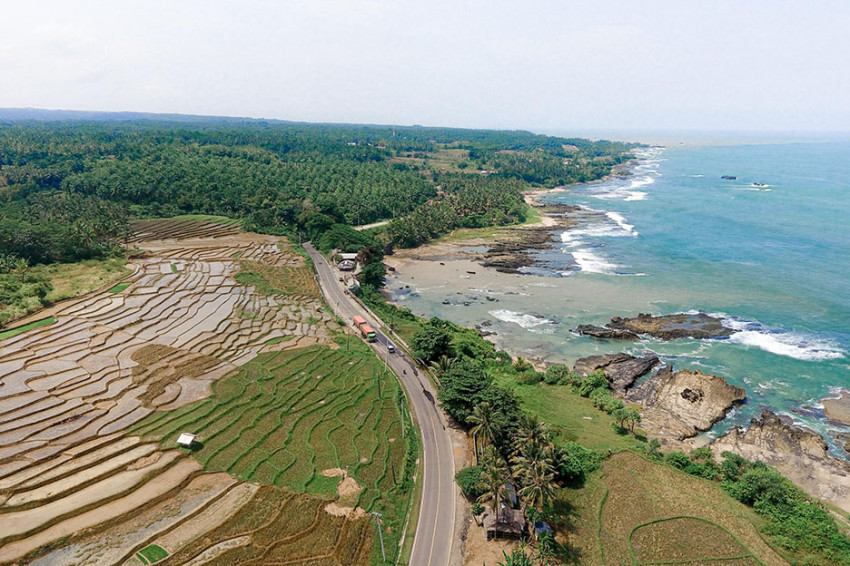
711, 410, 850, 512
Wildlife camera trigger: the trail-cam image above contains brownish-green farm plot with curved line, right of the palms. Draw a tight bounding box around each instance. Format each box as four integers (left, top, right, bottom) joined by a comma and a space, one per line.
570, 452, 787, 566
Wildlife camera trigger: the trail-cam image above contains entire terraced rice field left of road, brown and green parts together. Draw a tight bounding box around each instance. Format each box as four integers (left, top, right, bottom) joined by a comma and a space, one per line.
0, 218, 390, 566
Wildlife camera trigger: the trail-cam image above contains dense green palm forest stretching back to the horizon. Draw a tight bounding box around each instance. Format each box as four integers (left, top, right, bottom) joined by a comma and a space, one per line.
0, 115, 635, 265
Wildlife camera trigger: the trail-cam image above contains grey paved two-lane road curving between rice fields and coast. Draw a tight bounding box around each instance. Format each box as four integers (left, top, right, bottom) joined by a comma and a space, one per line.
304, 243, 456, 566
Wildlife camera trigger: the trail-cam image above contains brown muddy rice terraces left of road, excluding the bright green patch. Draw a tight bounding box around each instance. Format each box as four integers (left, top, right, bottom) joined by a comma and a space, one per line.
0, 220, 380, 566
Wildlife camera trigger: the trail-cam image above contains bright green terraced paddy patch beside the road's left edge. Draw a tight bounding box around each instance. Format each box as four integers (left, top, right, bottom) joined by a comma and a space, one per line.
131, 340, 418, 564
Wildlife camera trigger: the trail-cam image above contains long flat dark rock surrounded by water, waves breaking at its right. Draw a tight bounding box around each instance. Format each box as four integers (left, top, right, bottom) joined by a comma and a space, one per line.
606, 313, 732, 340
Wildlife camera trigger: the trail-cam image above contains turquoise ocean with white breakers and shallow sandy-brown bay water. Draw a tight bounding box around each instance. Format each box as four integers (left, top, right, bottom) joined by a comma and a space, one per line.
388, 141, 850, 448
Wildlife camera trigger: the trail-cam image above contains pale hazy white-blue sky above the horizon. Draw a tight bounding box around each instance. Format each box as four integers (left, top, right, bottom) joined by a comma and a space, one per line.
0, 0, 850, 133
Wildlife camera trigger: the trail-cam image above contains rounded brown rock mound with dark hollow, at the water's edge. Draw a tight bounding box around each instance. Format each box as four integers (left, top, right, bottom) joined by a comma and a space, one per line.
625, 366, 747, 442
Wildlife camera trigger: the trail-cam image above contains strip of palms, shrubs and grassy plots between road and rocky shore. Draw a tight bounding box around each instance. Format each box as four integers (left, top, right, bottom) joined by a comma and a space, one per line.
366, 295, 850, 566
